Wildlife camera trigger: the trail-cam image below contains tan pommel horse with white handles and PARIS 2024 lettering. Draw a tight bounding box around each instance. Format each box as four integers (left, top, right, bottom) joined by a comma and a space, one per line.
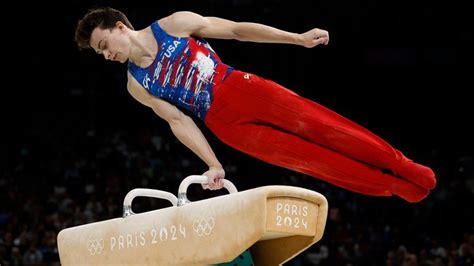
57, 176, 328, 266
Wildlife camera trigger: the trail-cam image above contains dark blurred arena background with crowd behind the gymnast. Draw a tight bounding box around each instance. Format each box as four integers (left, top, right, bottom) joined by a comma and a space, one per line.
0, 0, 474, 266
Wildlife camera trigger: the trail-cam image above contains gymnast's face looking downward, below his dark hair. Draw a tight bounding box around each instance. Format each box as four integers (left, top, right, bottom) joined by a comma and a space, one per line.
90, 22, 130, 63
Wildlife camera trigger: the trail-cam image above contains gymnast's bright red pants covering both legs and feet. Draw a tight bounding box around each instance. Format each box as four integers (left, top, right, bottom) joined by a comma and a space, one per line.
205, 71, 436, 202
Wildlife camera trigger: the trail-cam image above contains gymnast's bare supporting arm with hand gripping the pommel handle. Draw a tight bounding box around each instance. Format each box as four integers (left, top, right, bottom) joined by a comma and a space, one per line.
127, 73, 225, 189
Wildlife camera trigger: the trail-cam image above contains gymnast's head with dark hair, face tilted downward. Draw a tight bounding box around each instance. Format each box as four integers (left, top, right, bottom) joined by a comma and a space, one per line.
75, 7, 134, 63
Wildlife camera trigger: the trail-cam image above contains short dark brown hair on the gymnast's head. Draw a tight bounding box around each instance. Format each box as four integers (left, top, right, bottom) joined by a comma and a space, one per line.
74, 7, 133, 49
